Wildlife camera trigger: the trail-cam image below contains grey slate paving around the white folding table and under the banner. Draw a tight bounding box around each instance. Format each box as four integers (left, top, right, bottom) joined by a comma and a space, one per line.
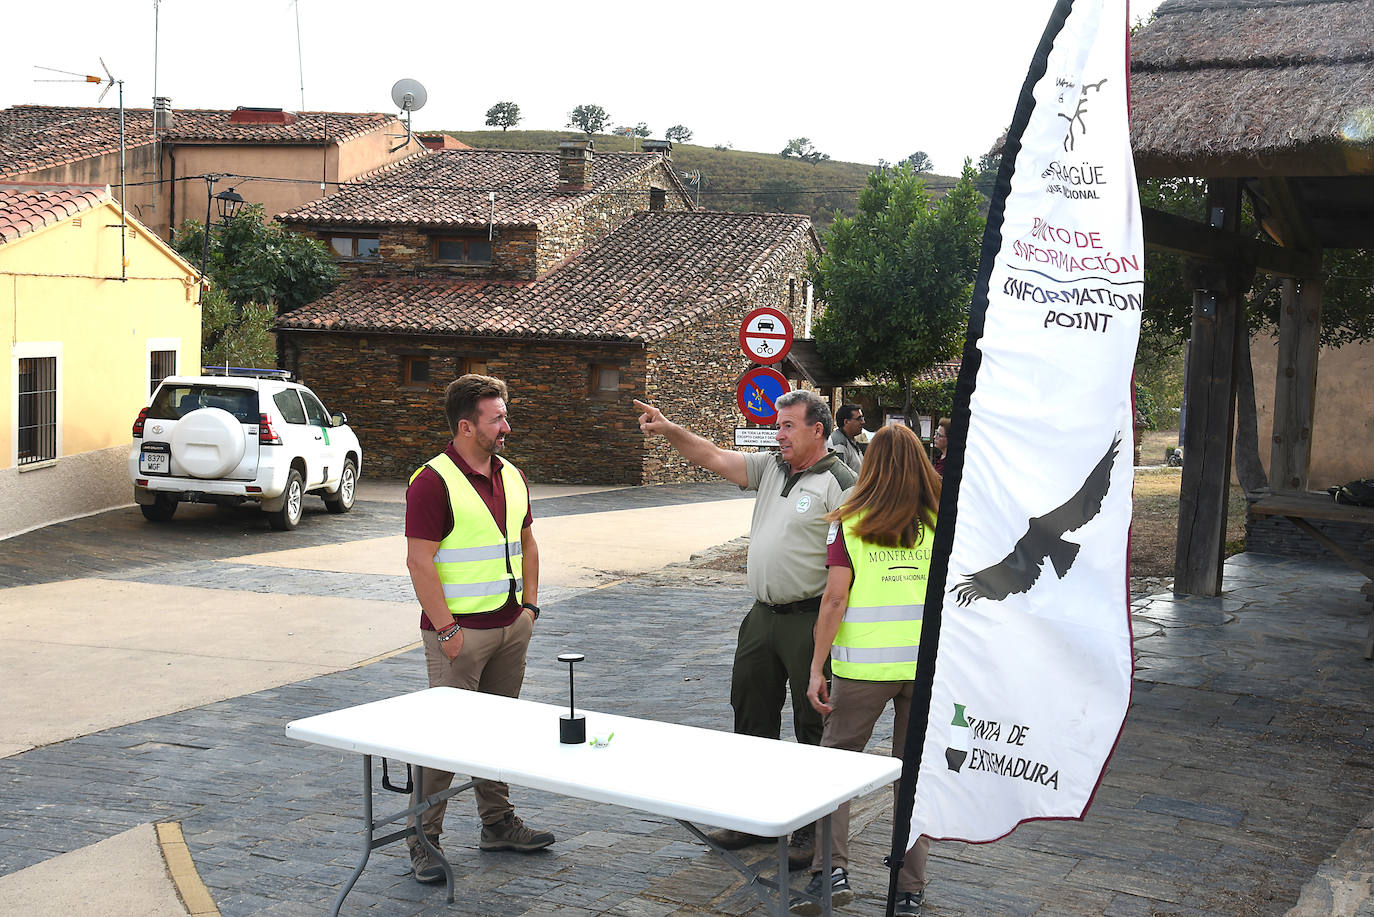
0, 488, 1374, 917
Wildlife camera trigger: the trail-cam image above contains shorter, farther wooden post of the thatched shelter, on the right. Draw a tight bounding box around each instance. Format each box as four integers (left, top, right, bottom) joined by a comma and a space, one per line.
1270, 278, 1322, 492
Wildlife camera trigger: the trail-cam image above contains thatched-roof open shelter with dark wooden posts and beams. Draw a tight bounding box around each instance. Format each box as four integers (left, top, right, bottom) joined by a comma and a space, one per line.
1131, 0, 1374, 595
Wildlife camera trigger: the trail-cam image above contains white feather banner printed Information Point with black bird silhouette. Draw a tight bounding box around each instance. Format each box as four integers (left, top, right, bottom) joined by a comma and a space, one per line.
904, 0, 1143, 841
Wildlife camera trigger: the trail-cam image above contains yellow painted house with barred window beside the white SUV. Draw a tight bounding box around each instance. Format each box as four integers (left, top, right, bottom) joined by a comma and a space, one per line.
0, 183, 201, 539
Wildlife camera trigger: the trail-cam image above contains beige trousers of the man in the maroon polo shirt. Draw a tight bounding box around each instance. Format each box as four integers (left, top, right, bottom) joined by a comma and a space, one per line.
411, 612, 534, 843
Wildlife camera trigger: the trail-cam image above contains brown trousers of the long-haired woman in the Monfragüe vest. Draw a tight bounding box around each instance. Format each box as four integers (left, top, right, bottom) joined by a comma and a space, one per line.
811, 676, 930, 892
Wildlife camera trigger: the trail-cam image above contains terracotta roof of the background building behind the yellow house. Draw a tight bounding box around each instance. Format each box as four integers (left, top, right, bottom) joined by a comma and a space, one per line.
0, 104, 396, 179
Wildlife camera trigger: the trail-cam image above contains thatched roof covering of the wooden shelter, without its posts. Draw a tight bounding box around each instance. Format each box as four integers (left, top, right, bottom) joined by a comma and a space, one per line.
1131, 0, 1374, 177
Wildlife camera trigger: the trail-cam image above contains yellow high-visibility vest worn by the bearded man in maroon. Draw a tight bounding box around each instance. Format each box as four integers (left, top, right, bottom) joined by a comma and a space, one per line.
411, 454, 529, 617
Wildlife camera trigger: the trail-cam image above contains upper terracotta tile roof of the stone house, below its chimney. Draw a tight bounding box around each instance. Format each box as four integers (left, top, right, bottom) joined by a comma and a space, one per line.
280, 150, 681, 227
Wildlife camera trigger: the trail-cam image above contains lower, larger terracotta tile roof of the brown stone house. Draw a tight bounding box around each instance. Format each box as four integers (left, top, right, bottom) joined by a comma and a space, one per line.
278, 210, 815, 341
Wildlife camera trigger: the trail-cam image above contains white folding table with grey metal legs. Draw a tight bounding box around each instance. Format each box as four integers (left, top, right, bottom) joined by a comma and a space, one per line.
286, 687, 901, 917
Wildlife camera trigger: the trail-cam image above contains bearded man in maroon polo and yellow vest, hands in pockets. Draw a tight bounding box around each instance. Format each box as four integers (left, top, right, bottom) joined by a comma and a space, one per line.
405, 374, 554, 884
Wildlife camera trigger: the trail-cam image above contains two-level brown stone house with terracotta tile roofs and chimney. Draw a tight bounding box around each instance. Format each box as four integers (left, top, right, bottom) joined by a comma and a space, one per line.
278, 143, 819, 484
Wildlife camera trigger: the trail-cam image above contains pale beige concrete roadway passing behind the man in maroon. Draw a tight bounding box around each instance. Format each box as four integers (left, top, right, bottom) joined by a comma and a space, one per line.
0, 483, 752, 755
